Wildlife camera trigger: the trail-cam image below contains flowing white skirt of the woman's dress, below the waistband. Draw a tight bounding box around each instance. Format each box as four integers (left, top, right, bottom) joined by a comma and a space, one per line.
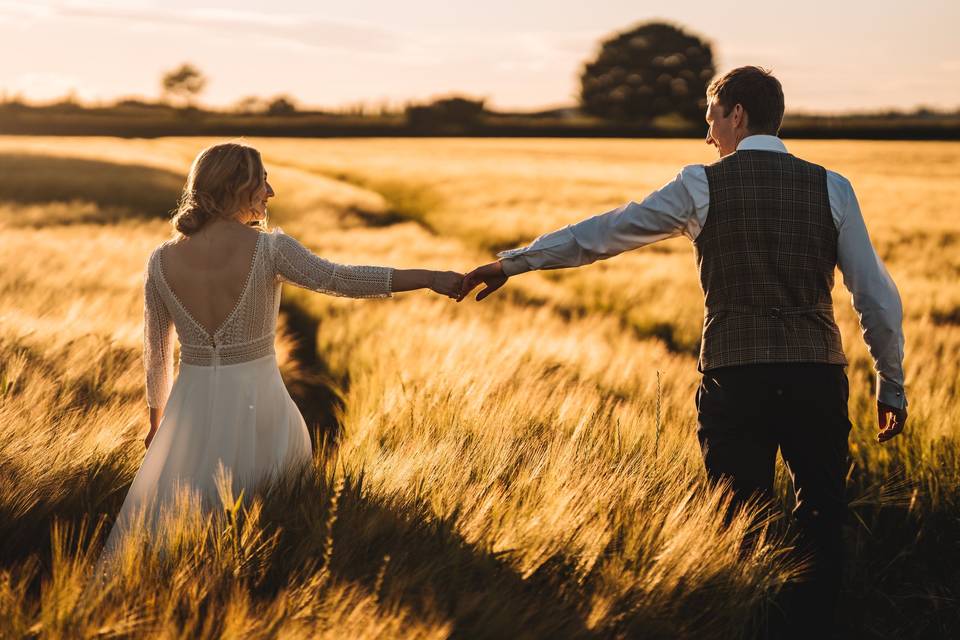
97, 353, 312, 568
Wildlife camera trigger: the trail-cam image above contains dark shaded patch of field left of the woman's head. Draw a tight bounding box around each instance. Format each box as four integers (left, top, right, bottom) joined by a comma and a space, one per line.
0, 153, 185, 226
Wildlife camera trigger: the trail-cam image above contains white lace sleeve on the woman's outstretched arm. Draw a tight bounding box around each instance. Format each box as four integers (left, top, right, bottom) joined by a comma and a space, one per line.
273, 228, 393, 298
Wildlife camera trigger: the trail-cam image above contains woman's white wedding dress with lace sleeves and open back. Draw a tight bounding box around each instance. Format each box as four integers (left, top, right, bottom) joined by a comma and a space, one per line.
98, 228, 393, 567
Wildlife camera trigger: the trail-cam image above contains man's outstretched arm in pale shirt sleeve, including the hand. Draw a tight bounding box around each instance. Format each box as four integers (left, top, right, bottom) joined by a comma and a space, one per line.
458, 164, 709, 301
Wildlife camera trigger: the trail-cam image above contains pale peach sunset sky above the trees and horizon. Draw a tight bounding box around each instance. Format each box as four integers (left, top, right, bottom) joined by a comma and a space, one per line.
0, 0, 960, 113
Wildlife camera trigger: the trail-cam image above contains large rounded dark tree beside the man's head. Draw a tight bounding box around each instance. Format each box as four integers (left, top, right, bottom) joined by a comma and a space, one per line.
580, 22, 715, 122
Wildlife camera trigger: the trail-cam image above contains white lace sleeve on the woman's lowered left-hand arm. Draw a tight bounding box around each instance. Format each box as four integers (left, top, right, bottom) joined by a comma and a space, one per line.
143, 254, 174, 409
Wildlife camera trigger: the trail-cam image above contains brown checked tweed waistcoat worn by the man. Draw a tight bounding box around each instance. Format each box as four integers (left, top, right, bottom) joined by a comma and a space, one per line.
694, 150, 847, 372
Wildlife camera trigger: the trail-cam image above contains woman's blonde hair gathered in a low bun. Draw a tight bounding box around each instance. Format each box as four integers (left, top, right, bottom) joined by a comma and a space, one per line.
171, 142, 266, 236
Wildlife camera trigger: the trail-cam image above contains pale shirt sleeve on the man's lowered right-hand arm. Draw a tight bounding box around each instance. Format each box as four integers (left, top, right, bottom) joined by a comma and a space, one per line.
828, 172, 907, 408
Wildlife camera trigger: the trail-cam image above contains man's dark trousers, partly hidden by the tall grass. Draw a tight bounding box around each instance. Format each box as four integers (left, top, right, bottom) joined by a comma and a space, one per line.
697, 362, 850, 637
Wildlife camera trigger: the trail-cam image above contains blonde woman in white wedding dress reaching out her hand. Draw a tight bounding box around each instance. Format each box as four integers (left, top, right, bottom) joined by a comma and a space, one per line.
98, 143, 462, 564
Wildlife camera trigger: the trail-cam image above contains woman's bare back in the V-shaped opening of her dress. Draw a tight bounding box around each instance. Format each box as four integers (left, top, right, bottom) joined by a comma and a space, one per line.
160, 223, 260, 336
